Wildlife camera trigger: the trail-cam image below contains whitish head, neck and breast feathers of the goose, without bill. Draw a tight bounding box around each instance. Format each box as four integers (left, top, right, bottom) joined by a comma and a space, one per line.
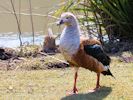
59, 12, 81, 61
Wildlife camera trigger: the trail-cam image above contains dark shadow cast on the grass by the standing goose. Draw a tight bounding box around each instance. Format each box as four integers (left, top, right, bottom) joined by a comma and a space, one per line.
61, 87, 112, 100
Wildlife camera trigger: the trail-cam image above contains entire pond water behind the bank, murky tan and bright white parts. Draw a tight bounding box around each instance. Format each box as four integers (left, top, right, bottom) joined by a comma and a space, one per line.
0, 0, 64, 48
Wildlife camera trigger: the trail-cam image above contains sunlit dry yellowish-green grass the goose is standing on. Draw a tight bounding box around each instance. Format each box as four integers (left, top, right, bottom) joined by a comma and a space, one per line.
0, 57, 133, 100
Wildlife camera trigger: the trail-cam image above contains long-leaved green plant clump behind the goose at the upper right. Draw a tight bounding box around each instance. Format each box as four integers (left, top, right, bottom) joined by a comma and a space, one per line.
55, 0, 133, 42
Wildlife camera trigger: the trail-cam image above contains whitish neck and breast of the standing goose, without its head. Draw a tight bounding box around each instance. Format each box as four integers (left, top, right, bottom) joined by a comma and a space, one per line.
60, 25, 80, 55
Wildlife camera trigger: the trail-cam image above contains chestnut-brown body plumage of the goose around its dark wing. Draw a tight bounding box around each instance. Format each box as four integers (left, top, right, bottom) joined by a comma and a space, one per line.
70, 39, 104, 73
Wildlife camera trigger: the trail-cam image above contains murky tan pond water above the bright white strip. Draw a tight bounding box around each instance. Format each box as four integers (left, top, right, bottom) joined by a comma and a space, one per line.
0, 0, 64, 33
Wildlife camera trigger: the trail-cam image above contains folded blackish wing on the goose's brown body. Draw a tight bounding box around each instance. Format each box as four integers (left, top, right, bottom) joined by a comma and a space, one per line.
84, 44, 111, 66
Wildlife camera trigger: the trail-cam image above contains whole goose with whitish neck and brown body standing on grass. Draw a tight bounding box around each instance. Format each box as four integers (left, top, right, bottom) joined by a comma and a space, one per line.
58, 12, 114, 93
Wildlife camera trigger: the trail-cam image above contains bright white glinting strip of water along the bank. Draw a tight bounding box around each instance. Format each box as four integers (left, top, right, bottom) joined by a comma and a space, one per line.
0, 32, 44, 48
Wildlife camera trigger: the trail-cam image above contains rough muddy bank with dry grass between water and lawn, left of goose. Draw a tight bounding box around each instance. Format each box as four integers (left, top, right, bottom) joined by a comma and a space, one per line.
0, 46, 69, 70
